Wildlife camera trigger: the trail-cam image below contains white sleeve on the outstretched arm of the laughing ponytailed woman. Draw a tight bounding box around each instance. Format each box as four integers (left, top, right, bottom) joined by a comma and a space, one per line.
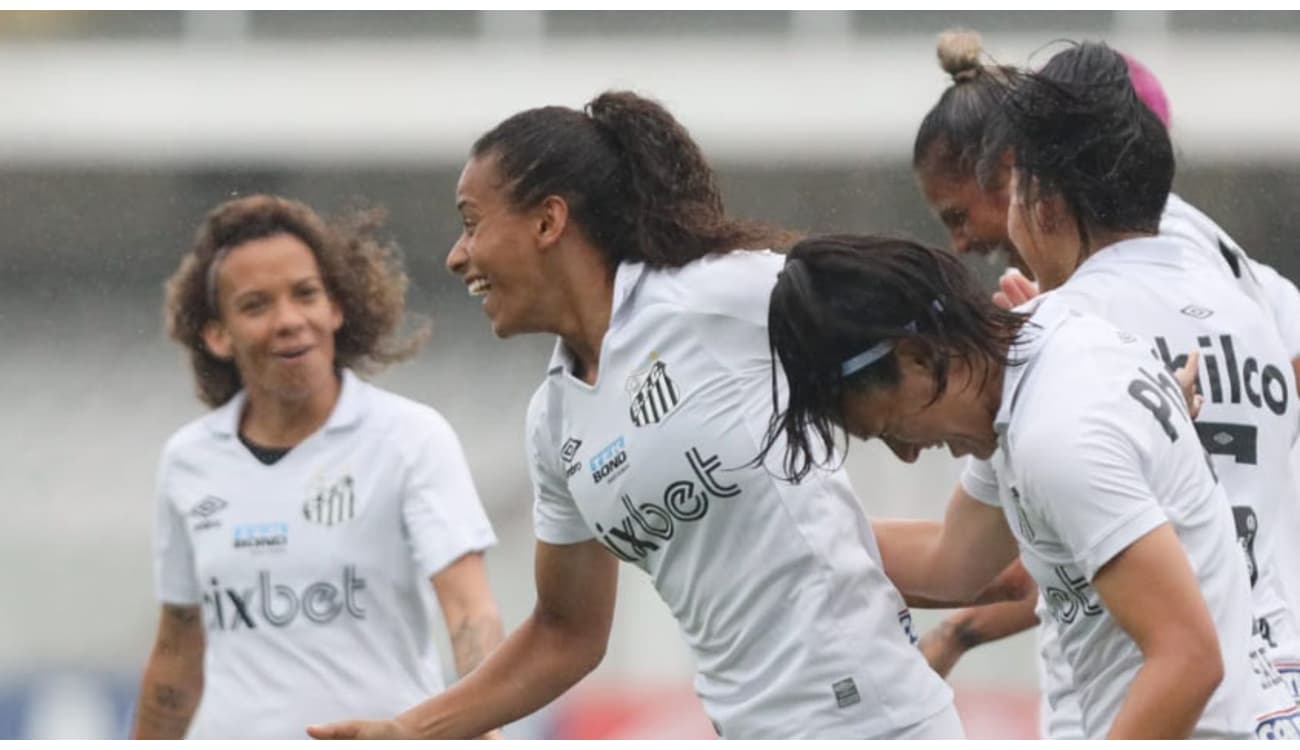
525, 383, 594, 545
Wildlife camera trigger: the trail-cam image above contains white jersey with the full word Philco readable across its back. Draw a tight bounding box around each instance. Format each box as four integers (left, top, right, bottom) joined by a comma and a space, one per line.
1054, 235, 1300, 737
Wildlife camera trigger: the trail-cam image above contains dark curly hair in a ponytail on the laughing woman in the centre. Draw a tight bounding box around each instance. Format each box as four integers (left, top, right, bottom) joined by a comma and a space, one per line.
471, 91, 789, 268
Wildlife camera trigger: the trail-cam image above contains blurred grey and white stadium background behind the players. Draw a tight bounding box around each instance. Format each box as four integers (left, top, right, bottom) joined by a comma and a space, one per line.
0, 10, 1300, 738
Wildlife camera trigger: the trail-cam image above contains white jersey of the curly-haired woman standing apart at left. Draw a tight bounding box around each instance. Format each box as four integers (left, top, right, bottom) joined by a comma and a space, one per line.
153, 370, 495, 740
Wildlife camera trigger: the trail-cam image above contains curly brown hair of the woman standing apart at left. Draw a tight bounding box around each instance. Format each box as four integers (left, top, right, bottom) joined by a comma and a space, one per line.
164, 189, 429, 408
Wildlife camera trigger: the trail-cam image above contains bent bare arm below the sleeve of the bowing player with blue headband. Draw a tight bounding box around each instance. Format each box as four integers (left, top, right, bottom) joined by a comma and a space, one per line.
1092, 524, 1223, 740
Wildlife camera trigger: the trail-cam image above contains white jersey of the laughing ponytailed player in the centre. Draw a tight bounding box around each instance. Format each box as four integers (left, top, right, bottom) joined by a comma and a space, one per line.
528, 251, 952, 738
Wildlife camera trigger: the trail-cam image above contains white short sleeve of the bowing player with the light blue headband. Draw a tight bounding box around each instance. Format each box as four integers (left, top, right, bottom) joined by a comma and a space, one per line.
1013, 415, 1167, 581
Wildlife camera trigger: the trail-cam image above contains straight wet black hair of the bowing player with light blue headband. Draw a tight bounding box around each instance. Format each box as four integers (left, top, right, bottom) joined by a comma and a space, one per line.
755, 234, 1026, 481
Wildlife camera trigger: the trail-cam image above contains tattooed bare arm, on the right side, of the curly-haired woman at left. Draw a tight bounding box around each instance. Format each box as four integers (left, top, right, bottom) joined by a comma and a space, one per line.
433, 552, 506, 677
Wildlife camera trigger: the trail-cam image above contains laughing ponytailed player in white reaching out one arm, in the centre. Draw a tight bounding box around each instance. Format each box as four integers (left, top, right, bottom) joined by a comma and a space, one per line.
301, 92, 962, 738
